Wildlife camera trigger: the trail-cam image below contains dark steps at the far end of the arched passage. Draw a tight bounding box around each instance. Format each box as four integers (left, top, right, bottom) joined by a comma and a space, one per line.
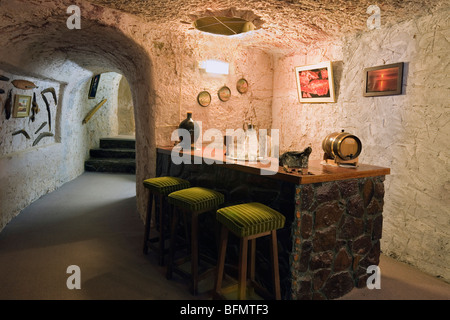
84, 136, 136, 173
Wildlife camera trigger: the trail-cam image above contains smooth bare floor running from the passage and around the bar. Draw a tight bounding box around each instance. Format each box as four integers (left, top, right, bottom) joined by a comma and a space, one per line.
0, 172, 450, 300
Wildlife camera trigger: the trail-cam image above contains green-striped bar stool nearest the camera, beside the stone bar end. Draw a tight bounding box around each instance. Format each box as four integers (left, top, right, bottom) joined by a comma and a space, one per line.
214, 202, 286, 300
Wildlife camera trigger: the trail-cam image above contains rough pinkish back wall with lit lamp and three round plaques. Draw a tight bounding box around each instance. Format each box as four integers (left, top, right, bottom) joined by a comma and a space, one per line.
152, 33, 273, 145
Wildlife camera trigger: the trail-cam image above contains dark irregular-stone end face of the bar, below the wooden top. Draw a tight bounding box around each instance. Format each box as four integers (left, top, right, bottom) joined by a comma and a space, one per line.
290, 176, 384, 299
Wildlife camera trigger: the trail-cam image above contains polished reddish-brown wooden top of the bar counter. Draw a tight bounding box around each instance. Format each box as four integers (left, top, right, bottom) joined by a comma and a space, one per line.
157, 146, 390, 184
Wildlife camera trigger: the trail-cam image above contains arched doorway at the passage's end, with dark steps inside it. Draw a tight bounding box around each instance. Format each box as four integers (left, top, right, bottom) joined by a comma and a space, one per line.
81, 72, 136, 173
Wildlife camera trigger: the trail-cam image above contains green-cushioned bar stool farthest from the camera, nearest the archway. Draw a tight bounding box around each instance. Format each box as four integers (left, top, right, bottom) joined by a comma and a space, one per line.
144, 177, 190, 265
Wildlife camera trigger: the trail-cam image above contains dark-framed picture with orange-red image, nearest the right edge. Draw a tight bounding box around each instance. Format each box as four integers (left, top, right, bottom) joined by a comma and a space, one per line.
363, 62, 403, 97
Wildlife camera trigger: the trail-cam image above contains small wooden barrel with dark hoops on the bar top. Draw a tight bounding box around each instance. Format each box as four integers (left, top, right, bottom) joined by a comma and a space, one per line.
322, 130, 362, 161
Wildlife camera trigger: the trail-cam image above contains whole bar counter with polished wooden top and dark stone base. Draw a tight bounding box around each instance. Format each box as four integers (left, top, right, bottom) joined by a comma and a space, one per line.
156, 147, 390, 299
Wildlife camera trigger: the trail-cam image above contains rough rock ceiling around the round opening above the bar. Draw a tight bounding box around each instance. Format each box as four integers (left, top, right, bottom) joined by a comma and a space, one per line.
85, 0, 449, 50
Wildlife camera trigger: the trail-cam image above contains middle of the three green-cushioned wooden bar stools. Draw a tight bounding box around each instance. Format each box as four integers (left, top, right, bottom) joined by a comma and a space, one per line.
166, 187, 225, 295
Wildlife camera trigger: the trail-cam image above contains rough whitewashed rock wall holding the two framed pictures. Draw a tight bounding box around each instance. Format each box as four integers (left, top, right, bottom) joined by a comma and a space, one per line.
273, 9, 450, 281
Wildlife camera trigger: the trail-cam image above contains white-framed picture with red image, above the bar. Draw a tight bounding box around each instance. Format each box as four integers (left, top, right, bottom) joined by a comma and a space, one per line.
295, 61, 335, 103
